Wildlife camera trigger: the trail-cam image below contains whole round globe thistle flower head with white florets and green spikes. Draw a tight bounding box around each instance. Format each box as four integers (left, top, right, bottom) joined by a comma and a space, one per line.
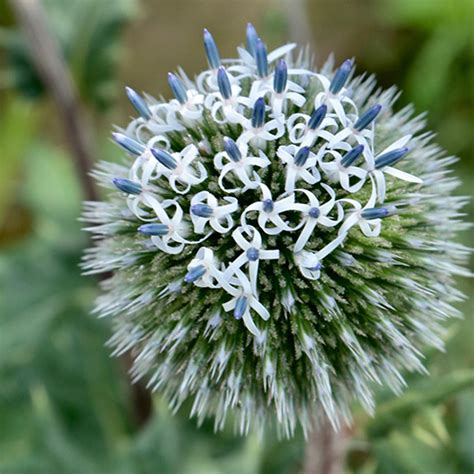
83, 25, 467, 436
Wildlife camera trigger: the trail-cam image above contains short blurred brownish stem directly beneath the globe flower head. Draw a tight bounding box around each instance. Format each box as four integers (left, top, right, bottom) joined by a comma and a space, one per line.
303, 418, 350, 474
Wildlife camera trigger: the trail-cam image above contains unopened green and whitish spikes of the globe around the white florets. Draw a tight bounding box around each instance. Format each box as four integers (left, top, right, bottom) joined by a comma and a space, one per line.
84, 48, 467, 436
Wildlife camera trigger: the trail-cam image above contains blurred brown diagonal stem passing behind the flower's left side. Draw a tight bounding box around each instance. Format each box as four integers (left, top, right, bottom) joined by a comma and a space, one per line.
10, 0, 152, 426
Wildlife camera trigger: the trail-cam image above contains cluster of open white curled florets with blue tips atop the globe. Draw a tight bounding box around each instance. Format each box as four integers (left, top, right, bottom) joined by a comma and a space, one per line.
114, 25, 421, 340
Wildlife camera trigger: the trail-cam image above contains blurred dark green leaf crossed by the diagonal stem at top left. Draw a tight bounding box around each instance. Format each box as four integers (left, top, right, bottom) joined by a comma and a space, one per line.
0, 0, 135, 108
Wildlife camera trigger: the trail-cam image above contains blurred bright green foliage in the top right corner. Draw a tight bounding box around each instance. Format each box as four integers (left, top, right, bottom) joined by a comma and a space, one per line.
379, 0, 474, 165
